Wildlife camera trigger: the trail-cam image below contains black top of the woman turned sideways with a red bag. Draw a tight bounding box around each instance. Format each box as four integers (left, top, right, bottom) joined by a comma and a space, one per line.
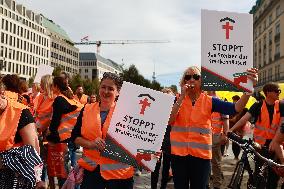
46, 96, 77, 143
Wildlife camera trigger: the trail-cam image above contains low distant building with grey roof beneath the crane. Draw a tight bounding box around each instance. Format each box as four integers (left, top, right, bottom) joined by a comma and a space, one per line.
79, 53, 122, 80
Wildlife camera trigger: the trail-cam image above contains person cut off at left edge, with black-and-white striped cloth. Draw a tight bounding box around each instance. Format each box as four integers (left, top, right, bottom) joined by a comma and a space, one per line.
0, 91, 44, 189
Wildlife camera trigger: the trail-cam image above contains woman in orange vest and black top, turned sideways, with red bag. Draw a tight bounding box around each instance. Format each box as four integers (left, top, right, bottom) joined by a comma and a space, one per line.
46, 77, 82, 188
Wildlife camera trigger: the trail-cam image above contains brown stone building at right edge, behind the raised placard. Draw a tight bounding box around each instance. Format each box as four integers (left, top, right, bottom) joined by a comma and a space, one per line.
250, 0, 284, 89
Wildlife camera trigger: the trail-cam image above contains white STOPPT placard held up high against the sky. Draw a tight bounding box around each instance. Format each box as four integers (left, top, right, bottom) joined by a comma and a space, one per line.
201, 10, 253, 92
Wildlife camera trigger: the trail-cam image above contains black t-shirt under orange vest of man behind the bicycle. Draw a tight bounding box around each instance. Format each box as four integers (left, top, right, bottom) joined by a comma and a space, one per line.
248, 100, 284, 124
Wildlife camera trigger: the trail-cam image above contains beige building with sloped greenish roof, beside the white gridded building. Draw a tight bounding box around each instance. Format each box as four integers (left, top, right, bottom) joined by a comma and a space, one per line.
42, 16, 79, 75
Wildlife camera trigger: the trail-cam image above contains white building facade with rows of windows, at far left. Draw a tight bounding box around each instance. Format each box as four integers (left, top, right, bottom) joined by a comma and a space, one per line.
0, 0, 50, 79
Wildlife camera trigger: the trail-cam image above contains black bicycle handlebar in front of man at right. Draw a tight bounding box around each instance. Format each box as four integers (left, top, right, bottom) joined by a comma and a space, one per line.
227, 132, 284, 168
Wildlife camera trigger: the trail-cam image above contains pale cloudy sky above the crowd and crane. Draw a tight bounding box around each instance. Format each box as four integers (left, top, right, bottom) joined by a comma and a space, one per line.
16, 0, 255, 86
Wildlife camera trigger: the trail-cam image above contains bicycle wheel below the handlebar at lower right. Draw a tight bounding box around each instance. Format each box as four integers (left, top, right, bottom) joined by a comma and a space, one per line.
228, 162, 245, 189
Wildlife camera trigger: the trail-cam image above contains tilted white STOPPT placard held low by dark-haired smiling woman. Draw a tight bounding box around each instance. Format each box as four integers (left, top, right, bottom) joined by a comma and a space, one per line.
102, 82, 175, 171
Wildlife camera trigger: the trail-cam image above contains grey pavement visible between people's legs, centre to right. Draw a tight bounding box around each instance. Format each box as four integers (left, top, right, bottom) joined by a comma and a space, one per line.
134, 141, 282, 189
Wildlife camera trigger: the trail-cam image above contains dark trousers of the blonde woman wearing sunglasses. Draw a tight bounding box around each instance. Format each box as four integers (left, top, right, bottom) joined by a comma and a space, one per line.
171, 155, 210, 189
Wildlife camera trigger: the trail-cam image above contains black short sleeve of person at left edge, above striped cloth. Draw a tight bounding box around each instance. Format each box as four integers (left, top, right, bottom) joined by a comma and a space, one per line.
14, 109, 35, 143
